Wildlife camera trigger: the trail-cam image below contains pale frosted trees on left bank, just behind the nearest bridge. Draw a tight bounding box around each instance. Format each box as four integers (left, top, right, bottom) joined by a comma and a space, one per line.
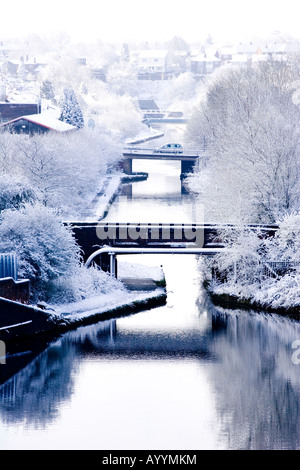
12, 129, 121, 217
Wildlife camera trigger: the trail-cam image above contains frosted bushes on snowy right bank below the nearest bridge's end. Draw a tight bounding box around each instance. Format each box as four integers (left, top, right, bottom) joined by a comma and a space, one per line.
206, 214, 300, 313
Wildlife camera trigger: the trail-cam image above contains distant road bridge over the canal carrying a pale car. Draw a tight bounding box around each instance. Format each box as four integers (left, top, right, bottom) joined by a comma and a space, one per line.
122, 147, 207, 176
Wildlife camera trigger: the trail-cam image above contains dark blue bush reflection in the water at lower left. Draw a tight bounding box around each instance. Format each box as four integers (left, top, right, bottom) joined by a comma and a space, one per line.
0, 332, 76, 427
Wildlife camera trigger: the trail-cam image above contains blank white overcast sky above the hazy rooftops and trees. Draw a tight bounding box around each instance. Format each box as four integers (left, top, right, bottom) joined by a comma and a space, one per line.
0, 0, 300, 42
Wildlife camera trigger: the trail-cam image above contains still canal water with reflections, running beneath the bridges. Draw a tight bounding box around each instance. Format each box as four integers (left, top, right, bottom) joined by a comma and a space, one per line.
0, 139, 300, 450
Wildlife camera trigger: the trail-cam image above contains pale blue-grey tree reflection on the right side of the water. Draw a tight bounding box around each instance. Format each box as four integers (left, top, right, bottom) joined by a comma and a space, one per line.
210, 311, 300, 449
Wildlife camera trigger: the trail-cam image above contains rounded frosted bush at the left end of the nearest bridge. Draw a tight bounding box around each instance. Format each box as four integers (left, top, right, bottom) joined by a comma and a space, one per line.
0, 204, 80, 300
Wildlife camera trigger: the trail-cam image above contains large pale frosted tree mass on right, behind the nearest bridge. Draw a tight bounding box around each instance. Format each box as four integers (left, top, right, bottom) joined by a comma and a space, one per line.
187, 62, 300, 223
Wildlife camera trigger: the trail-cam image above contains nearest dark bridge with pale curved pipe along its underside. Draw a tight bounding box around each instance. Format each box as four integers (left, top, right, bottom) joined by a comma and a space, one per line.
65, 221, 278, 276
